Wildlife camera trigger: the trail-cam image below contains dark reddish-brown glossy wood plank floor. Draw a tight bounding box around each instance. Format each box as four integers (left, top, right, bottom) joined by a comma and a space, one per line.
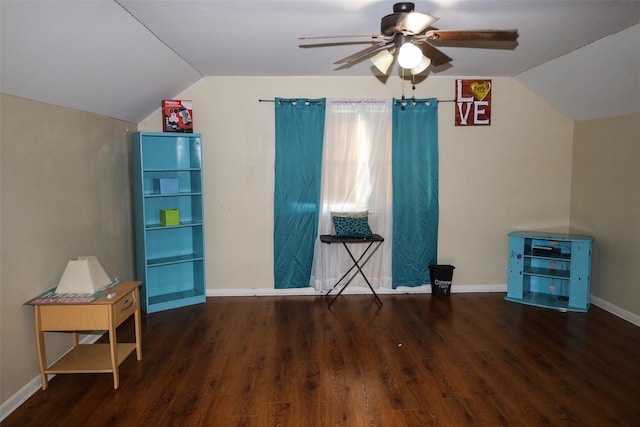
2, 294, 640, 427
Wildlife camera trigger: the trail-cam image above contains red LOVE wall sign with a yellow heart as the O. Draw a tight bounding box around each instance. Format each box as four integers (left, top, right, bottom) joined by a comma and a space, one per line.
456, 79, 491, 126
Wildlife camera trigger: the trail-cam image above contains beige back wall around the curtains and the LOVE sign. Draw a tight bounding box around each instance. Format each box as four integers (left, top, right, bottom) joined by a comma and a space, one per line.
139, 77, 573, 290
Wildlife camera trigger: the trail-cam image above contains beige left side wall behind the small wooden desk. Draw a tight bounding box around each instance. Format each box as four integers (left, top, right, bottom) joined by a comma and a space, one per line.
0, 94, 136, 403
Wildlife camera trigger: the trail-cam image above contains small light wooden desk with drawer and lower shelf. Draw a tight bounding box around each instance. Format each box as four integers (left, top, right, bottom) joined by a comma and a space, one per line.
32, 281, 142, 390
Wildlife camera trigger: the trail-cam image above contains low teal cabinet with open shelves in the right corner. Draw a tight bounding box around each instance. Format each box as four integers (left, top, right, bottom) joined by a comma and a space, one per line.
505, 231, 593, 312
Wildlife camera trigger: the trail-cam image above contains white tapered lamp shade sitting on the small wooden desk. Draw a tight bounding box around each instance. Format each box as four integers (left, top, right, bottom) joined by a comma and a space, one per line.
56, 256, 112, 294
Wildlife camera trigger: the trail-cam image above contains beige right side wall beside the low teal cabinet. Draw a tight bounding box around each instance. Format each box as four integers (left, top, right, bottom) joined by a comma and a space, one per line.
571, 113, 640, 315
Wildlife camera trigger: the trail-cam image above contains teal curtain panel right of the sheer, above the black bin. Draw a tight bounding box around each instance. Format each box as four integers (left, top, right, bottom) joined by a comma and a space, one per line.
391, 98, 439, 288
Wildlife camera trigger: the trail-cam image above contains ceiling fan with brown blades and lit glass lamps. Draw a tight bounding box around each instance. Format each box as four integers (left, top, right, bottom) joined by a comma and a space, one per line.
300, 2, 518, 75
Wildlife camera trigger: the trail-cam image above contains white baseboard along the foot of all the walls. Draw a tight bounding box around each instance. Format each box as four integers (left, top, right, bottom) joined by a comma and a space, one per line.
0, 285, 640, 422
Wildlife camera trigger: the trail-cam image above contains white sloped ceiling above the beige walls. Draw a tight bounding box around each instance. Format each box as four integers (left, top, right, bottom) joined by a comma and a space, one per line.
0, 0, 640, 122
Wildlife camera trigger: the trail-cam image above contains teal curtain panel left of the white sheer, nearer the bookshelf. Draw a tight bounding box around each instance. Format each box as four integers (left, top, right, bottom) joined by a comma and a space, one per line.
273, 98, 326, 289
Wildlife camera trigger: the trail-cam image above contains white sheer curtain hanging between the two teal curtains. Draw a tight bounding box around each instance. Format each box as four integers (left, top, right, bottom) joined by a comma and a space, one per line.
311, 99, 392, 291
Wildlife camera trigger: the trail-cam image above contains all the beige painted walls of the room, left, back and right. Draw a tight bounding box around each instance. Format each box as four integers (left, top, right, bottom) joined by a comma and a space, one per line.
0, 77, 640, 412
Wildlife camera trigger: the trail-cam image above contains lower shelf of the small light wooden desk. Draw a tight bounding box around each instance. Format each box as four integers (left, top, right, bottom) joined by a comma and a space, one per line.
45, 343, 136, 374
